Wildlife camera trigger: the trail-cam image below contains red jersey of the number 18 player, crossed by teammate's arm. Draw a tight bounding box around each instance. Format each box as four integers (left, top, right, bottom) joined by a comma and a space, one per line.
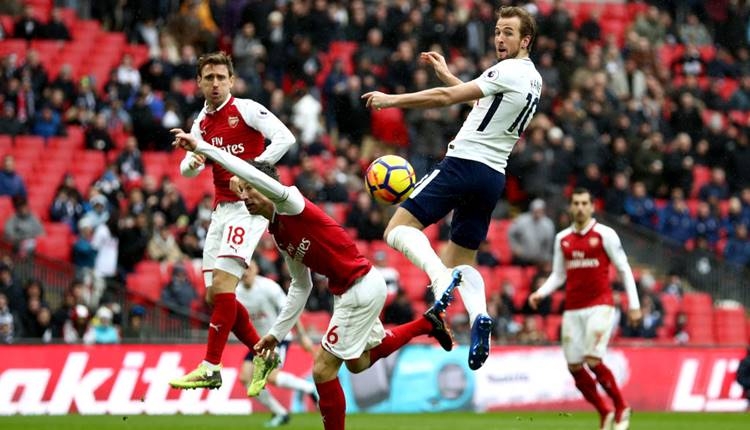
193, 97, 265, 206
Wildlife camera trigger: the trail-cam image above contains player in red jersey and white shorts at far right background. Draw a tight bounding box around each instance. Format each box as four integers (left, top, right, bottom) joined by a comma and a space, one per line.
529, 188, 641, 430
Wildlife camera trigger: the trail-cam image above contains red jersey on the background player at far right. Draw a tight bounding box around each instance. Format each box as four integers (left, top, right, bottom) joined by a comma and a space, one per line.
555, 223, 620, 310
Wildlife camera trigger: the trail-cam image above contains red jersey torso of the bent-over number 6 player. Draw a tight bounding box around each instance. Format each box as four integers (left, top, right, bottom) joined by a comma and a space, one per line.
268, 199, 372, 295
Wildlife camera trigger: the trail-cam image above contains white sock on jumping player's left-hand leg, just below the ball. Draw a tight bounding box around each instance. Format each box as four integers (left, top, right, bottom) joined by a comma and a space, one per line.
386, 225, 445, 284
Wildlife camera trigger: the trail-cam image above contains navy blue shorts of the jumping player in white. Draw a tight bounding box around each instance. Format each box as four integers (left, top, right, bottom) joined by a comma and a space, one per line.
401, 157, 505, 250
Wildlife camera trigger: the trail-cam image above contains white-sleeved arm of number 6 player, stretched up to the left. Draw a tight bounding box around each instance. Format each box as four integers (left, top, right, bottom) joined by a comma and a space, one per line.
170, 128, 289, 202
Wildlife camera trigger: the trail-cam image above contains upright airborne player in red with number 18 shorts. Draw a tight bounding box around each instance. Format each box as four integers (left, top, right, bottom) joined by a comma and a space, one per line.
169, 52, 295, 388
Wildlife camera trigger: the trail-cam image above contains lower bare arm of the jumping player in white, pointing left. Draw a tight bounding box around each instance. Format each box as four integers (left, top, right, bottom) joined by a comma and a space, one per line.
362, 82, 484, 109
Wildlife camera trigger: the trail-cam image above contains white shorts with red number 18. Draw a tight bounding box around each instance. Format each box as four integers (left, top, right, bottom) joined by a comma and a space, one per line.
203, 202, 268, 287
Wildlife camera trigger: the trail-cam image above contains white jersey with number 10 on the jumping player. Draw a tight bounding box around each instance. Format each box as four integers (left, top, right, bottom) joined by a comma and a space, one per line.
446, 58, 542, 173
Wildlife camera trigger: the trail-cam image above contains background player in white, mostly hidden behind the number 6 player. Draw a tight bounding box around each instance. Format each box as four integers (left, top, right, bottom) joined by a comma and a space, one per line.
236, 260, 318, 427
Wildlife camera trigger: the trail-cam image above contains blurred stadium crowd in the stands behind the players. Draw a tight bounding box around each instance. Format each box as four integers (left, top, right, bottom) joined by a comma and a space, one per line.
0, 0, 750, 343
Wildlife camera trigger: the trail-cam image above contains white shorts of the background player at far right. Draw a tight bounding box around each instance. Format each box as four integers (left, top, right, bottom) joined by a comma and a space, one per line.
562, 305, 615, 364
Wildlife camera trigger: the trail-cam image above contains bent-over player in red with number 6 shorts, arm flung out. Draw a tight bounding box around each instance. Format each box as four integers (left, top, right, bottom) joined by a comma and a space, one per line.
173, 130, 461, 430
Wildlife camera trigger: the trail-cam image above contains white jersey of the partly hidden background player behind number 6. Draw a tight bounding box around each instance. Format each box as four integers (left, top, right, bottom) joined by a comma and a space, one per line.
235, 275, 286, 336
